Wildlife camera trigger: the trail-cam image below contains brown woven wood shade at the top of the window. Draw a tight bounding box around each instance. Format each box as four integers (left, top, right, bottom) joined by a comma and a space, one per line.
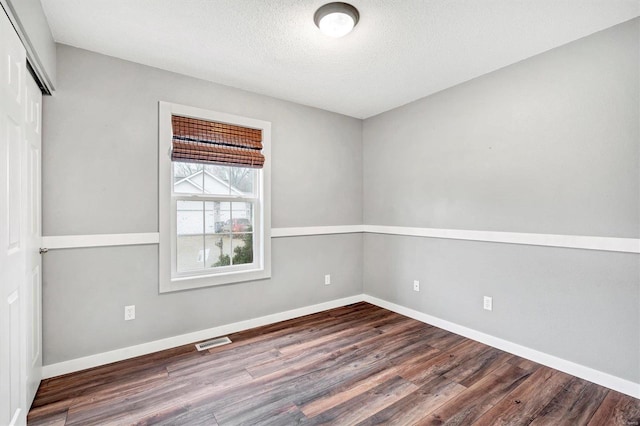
171, 115, 264, 169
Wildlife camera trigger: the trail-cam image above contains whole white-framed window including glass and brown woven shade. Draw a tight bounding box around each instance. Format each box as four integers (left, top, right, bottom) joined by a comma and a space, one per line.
159, 102, 271, 292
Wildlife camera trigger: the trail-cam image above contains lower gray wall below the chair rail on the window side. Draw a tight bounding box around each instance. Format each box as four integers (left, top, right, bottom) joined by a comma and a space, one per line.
43, 234, 363, 365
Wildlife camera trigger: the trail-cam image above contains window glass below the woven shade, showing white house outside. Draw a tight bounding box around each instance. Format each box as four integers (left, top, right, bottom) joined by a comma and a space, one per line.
173, 162, 259, 273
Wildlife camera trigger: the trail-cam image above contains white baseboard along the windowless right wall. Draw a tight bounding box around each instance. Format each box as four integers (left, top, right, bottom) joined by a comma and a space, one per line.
363, 294, 640, 398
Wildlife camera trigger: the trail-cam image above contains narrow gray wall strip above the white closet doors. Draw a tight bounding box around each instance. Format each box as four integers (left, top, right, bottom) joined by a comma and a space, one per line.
0, 0, 56, 89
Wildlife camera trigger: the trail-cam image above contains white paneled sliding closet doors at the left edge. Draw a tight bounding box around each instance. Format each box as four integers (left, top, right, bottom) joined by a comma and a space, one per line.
0, 8, 41, 425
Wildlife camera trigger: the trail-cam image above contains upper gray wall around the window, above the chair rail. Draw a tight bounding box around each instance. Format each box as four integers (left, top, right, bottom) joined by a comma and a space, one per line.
42, 45, 362, 235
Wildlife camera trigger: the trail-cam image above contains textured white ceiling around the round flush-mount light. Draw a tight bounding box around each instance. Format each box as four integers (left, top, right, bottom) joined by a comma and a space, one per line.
41, 0, 640, 118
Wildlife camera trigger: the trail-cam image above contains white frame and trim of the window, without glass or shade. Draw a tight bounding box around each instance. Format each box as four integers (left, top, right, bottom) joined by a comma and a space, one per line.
158, 102, 271, 293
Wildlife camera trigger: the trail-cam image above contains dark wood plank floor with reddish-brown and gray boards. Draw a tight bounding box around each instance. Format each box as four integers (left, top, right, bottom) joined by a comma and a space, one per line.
28, 303, 640, 426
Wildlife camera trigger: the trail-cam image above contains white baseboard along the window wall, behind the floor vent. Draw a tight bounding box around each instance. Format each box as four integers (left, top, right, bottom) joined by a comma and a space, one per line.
42, 294, 362, 379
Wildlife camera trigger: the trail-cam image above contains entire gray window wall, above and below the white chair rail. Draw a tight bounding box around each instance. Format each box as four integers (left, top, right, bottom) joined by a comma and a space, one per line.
42, 46, 363, 365
